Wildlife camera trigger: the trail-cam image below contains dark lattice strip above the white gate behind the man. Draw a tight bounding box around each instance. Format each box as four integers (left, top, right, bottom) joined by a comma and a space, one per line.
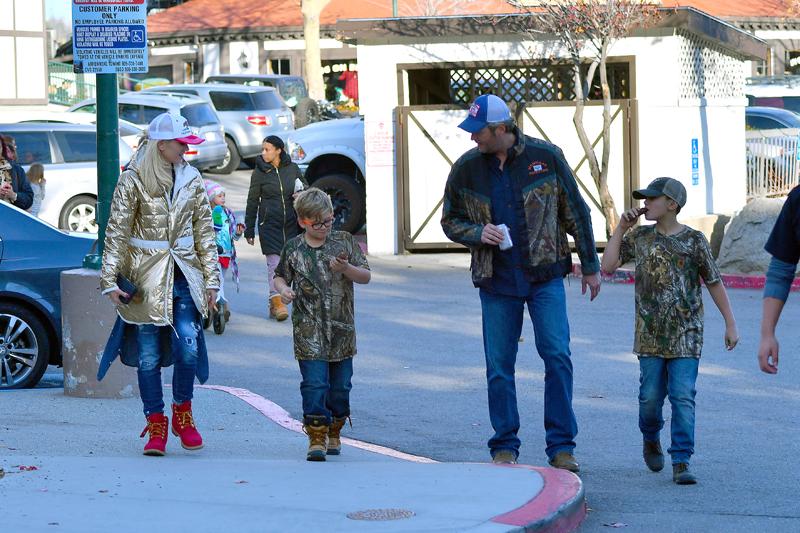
450, 63, 630, 106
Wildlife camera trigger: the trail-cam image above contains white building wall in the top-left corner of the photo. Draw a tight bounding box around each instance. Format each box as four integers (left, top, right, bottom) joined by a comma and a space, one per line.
0, 0, 47, 105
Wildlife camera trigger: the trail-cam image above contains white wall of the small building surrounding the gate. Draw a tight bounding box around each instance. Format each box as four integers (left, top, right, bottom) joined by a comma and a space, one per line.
358, 34, 746, 254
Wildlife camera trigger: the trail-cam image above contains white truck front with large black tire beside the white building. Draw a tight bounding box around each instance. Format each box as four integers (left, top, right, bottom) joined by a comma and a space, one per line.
286, 117, 367, 233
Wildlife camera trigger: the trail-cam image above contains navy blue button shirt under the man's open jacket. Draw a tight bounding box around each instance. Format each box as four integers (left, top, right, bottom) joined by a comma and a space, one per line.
490, 150, 531, 298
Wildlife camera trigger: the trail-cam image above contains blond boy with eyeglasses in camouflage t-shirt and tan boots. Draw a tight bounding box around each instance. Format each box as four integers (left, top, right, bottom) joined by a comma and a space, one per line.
275, 187, 370, 461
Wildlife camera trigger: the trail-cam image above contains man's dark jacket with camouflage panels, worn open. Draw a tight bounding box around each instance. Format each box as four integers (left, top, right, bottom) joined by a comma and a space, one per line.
442, 132, 600, 287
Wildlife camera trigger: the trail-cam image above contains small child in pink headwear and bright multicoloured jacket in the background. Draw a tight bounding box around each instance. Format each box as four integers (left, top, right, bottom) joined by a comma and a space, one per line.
204, 180, 244, 334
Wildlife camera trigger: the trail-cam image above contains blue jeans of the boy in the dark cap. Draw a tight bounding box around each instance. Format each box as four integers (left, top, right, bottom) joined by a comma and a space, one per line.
639, 357, 700, 464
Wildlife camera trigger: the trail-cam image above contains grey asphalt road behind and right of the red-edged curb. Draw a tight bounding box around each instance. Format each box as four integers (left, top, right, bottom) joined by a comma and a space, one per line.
40, 171, 800, 533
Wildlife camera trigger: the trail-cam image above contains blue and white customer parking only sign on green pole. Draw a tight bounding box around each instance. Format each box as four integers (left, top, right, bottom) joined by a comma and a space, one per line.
72, 0, 147, 74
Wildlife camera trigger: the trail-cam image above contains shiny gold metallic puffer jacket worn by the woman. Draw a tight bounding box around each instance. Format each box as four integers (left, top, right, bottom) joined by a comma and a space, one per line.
100, 150, 220, 326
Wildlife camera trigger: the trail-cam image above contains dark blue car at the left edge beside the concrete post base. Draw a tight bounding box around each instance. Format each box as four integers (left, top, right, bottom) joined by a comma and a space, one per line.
0, 202, 97, 389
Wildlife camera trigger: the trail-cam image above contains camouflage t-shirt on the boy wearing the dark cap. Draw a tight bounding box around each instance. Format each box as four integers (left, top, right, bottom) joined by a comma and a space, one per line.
620, 225, 721, 358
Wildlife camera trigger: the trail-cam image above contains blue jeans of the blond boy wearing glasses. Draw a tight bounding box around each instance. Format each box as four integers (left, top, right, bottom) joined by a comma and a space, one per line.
298, 357, 353, 425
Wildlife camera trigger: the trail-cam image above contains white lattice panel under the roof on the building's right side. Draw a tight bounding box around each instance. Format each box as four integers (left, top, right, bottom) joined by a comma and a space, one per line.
679, 33, 745, 100
